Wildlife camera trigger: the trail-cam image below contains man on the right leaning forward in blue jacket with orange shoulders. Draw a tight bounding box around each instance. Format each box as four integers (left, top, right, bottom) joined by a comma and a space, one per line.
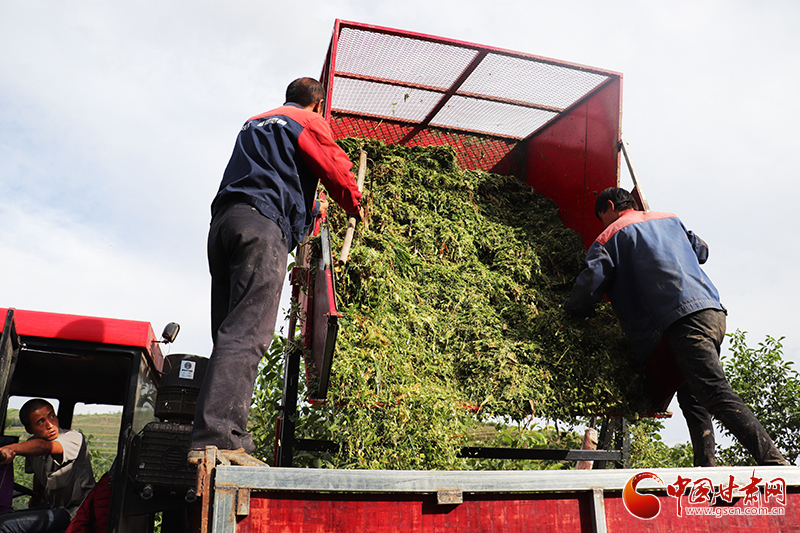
564, 187, 788, 466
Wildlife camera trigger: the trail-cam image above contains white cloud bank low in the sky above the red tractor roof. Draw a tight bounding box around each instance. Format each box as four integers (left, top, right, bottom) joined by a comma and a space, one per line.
0, 202, 210, 355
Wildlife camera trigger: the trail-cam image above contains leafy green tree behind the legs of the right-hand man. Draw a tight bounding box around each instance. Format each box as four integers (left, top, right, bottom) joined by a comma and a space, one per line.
718, 330, 800, 465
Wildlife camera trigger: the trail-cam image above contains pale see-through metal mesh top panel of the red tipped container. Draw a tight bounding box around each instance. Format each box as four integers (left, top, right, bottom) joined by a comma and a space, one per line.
329, 23, 617, 142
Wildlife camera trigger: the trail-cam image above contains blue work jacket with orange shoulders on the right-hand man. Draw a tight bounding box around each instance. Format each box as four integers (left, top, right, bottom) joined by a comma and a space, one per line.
564, 210, 725, 363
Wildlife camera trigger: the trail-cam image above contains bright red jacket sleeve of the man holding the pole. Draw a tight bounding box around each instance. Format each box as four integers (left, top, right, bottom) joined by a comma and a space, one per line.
297, 117, 361, 214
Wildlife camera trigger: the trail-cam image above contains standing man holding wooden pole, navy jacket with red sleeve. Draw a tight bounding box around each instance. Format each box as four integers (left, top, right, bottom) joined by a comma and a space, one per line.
189, 78, 361, 465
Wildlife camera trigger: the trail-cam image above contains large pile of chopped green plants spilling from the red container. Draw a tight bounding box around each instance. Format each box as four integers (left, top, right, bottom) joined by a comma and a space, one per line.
304, 139, 647, 468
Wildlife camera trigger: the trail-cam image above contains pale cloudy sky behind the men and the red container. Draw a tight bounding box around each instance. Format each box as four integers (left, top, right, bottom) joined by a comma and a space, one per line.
0, 0, 800, 441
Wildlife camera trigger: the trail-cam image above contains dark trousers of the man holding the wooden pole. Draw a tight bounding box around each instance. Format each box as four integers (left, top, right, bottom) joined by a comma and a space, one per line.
191, 204, 289, 453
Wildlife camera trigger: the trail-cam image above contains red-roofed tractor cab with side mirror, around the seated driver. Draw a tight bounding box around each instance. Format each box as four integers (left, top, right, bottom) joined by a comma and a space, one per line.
0, 309, 207, 531
